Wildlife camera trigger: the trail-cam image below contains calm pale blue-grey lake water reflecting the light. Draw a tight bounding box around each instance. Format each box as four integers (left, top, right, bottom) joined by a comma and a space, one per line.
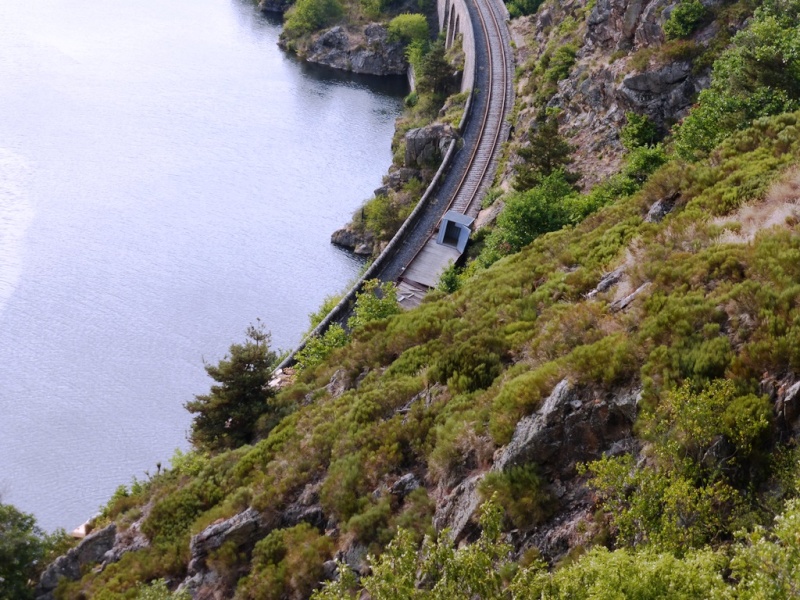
0, 0, 406, 530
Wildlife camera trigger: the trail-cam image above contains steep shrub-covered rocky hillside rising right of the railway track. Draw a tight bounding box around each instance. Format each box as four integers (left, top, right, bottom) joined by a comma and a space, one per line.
40, 0, 800, 598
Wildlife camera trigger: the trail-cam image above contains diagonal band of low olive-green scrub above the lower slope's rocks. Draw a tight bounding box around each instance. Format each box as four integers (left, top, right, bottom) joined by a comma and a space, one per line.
68, 114, 800, 597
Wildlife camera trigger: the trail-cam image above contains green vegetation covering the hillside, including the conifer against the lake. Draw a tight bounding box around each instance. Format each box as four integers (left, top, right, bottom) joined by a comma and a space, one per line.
20, 0, 800, 600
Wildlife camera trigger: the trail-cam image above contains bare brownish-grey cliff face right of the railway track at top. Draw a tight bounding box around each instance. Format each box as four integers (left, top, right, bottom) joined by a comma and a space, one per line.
506, 0, 740, 186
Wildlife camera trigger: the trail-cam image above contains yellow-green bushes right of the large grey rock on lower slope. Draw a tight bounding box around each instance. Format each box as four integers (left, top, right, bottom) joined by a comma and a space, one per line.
585, 380, 771, 554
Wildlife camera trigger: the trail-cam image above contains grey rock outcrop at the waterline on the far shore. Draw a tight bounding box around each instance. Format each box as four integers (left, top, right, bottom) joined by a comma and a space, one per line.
290, 23, 408, 75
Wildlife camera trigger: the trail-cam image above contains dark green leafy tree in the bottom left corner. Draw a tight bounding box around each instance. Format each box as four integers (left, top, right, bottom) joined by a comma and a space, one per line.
0, 504, 47, 600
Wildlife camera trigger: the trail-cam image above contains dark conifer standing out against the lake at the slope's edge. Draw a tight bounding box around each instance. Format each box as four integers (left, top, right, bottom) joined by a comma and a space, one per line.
185, 322, 277, 451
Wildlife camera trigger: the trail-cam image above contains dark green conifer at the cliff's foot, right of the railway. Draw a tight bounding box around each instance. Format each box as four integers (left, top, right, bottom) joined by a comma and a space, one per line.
514, 117, 578, 191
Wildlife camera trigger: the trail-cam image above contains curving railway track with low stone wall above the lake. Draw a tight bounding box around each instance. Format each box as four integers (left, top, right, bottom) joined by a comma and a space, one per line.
278, 0, 513, 369
